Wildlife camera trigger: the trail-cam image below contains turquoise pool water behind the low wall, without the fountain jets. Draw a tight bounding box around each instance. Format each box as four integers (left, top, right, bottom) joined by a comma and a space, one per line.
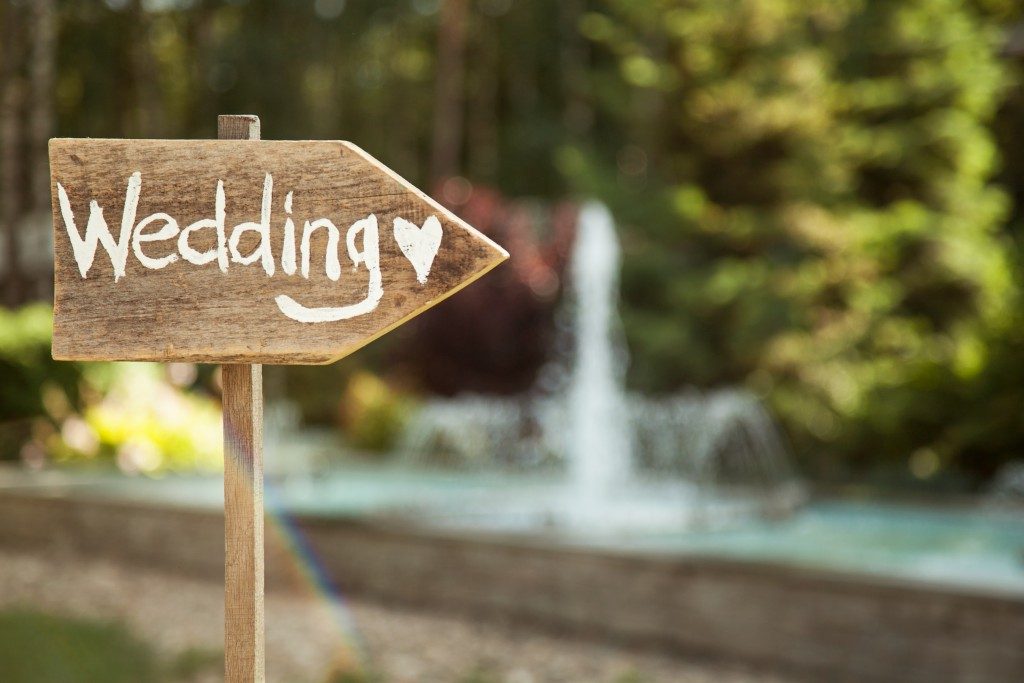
0, 468, 1024, 595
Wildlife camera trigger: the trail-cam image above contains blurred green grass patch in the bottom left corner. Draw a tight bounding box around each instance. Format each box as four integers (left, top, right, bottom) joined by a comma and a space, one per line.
0, 609, 222, 683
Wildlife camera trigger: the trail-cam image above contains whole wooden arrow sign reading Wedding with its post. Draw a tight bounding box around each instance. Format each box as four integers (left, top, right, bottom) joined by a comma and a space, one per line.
50, 116, 508, 683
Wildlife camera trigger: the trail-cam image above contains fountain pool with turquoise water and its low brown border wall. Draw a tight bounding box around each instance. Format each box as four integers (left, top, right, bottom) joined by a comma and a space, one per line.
0, 464, 1024, 683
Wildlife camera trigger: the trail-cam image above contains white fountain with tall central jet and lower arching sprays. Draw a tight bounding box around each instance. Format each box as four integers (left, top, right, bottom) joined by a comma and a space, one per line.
401, 202, 803, 535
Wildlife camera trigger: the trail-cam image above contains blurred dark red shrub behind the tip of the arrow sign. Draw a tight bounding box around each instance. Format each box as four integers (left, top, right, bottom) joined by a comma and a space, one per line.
389, 186, 575, 396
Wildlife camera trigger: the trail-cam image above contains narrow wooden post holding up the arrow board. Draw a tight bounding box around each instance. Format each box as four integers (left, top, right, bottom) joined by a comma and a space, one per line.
217, 116, 266, 683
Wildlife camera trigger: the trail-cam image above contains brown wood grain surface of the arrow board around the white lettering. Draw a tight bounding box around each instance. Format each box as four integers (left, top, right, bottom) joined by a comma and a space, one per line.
50, 135, 508, 364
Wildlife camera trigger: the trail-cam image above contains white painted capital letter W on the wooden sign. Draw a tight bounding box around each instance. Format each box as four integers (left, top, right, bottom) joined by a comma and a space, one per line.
57, 171, 142, 282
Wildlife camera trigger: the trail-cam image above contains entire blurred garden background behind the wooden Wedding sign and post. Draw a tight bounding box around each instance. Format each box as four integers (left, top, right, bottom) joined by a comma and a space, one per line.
0, 0, 1024, 683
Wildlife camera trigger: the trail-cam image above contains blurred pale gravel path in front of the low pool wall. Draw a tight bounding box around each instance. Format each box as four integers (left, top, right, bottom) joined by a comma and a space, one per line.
0, 550, 783, 683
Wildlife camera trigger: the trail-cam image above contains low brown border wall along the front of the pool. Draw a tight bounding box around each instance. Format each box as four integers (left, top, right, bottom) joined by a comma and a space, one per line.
0, 490, 1024, 683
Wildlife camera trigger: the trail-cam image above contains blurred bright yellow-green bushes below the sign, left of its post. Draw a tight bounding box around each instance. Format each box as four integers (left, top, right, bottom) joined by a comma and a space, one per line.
0, 305, 222, 473
